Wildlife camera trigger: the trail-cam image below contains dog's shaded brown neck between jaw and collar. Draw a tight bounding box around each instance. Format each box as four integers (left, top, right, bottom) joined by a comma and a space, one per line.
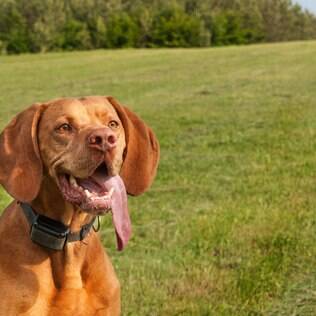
30, 176, 93, 231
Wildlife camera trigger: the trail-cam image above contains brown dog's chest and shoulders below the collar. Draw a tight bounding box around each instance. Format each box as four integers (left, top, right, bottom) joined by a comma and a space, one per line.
0, 210, 120, 316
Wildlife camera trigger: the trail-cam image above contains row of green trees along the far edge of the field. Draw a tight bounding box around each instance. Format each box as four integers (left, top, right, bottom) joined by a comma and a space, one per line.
0, 0, 316, 54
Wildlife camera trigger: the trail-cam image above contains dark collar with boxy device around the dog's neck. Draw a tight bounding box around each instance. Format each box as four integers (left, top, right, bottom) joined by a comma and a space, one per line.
19, 202, 96, 250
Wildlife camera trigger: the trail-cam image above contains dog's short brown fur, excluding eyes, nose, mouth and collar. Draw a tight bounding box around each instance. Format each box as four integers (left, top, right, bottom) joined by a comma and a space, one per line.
0, 97, 159, 316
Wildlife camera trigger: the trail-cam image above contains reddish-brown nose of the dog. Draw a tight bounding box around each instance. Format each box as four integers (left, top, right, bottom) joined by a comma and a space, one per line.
88, 127, 117, 152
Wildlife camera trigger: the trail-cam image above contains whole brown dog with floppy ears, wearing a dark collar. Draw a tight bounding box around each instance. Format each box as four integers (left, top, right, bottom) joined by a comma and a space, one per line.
0, 97, 159, 316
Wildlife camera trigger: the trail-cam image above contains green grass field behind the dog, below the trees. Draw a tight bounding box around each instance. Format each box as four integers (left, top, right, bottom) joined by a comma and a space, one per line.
0, 42, 316, 316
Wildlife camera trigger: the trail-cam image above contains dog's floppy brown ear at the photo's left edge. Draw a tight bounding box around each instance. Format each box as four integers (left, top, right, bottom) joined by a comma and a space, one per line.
0, 104, 43, 202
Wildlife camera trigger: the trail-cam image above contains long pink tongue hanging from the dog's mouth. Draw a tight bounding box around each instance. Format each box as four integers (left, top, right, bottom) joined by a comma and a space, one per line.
93, 175, 131, 250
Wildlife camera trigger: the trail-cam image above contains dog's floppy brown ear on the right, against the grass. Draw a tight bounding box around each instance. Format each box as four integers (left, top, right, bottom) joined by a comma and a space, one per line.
107, 97, 160, 195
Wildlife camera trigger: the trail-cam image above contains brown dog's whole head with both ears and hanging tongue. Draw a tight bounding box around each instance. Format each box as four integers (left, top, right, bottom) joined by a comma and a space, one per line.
0, 97, 159, 248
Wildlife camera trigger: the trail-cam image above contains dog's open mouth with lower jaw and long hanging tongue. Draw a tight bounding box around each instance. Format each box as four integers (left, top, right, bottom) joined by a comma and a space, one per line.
58, 163, 131, 250
